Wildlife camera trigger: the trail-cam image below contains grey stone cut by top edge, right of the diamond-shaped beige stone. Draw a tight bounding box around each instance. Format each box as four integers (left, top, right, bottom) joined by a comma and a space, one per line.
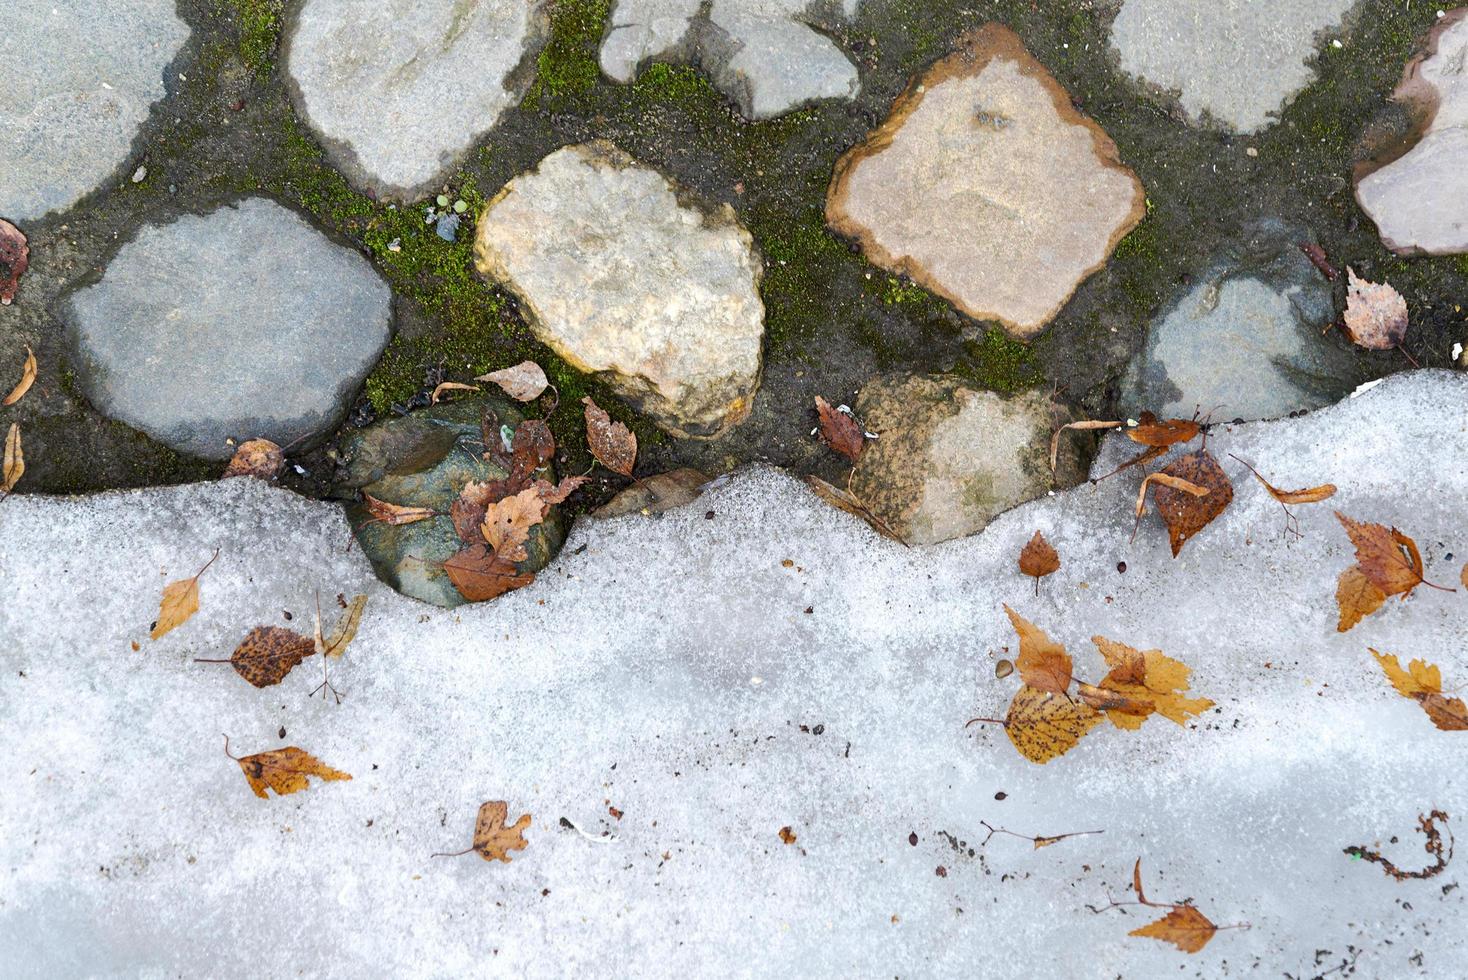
1111, 0, 1356, 132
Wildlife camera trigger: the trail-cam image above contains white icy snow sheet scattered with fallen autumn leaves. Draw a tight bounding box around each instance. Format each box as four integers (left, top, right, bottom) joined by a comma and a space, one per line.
0, 371, 1468, 979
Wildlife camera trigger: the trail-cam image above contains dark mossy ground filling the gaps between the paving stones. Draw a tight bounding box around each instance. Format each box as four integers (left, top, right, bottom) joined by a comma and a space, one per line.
12, 0, 1468, 502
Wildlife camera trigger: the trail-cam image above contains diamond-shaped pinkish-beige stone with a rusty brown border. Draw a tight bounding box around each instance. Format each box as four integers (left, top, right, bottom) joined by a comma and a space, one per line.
826, 23, 1145, 337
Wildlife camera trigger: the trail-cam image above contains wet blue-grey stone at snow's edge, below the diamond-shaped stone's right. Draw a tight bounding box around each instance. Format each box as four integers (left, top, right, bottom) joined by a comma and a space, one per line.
1120, 220, 1365, 420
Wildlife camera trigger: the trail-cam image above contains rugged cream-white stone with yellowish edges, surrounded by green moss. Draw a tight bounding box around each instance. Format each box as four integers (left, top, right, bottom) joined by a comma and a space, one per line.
474, 141, 765, 436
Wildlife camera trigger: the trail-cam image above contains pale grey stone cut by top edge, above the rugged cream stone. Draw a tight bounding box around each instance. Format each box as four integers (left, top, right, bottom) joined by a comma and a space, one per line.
285, 0, 546, 200
